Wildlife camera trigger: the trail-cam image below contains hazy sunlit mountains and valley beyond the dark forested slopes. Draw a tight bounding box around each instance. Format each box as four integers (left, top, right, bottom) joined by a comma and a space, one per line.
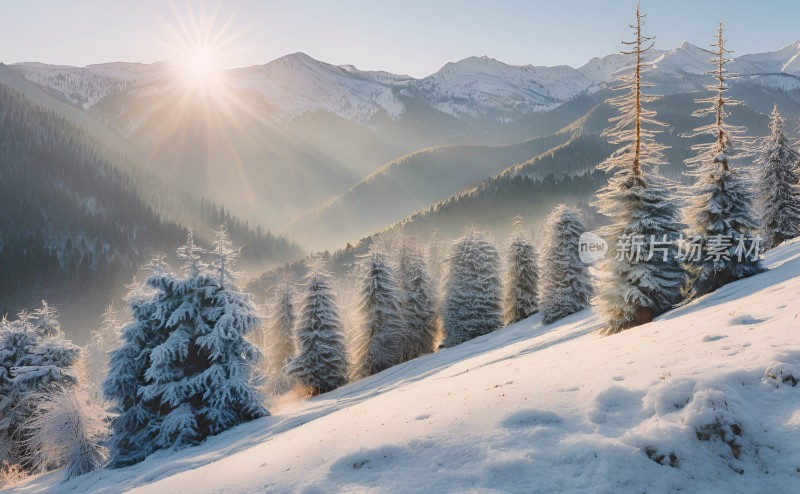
10, 42, 800, 249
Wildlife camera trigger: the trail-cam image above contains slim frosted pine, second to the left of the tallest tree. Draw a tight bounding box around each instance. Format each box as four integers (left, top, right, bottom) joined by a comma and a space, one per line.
504, 216, 539, 324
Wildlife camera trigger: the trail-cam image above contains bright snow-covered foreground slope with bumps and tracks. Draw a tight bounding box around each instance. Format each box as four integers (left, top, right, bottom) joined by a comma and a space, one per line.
12, 242, 800, 493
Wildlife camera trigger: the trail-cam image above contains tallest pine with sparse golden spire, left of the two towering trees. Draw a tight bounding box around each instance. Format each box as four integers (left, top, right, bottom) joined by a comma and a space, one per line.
593, 7, 685, 334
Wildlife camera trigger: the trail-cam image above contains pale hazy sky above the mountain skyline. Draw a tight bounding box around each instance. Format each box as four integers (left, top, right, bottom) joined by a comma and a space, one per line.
0, 0, 800, 77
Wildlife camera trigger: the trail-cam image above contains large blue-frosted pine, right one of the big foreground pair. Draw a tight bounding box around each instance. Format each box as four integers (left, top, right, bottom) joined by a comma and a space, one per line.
140, 228, 269, 448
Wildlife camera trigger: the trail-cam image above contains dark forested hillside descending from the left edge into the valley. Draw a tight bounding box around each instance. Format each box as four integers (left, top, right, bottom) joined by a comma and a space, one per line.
0, 85, 299, 341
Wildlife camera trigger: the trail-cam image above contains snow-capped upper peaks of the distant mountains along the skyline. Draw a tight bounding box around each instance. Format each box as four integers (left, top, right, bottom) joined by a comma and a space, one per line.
13, 41, 800, 123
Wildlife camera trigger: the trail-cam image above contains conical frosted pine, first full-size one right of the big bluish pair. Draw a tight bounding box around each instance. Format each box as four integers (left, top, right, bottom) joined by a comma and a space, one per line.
285, 260, 348, 395
